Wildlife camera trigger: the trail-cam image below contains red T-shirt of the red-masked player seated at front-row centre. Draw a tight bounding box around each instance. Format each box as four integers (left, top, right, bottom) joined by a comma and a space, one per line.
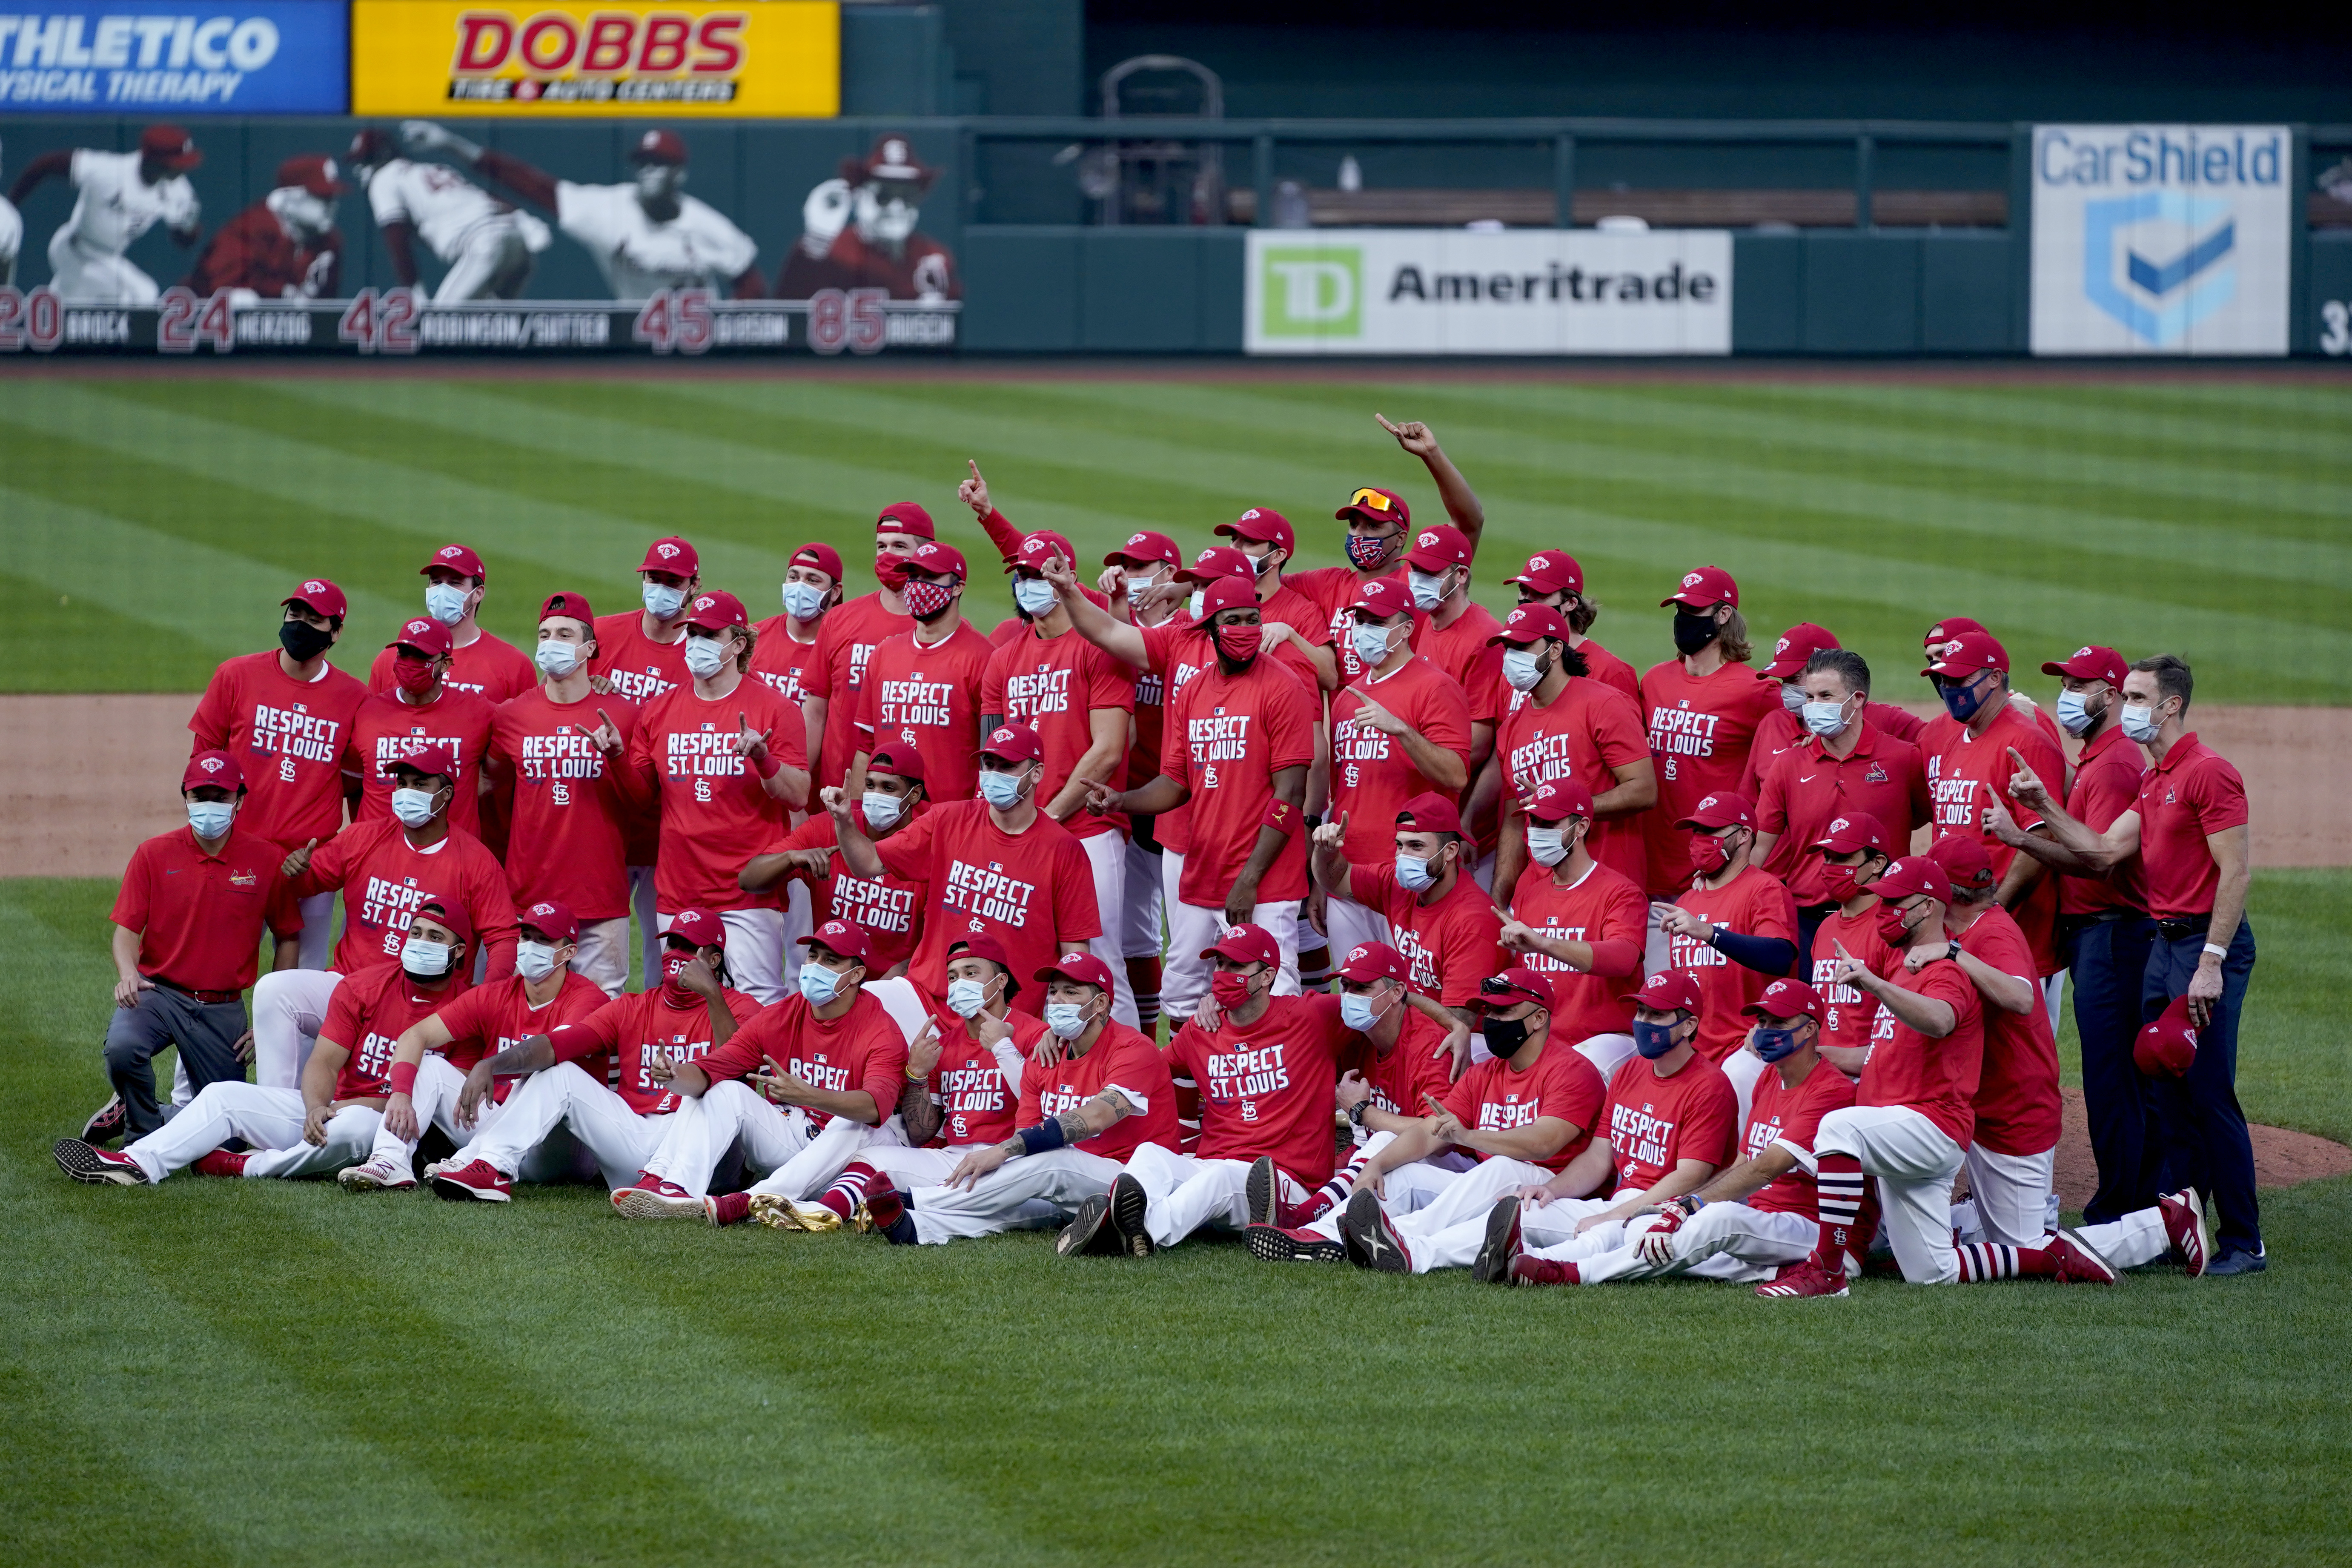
1169, 995, 1355, 1187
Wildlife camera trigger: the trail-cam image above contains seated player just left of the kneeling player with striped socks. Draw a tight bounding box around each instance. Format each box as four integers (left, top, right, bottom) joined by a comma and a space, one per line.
1505, 976, 1868, 1286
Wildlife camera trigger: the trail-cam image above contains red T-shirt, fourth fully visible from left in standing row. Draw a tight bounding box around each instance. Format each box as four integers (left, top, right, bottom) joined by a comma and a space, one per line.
621, 679, 809, 914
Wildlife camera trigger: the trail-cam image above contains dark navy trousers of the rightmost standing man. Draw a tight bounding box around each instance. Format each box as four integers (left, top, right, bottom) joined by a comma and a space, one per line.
2140, 919, 2263, 1253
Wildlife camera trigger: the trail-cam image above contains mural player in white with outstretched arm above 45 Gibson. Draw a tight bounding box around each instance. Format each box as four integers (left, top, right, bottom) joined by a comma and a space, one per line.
400, 120, 765, 306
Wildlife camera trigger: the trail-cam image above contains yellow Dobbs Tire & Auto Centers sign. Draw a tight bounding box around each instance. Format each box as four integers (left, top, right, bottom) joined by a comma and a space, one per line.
350, 0, 842, 120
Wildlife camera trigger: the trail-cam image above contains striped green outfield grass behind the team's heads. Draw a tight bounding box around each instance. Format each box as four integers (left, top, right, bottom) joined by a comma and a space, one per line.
0, 369, 2352, 703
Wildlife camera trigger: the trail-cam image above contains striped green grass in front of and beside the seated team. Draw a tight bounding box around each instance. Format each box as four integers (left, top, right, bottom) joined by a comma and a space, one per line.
0, 872, 2352, 1568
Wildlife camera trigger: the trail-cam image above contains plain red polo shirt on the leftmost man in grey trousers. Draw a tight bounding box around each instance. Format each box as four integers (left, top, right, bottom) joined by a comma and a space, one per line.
108, 823, 301, 992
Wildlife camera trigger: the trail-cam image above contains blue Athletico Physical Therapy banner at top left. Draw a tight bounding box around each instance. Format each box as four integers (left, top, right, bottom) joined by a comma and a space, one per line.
0, 0, 348, 115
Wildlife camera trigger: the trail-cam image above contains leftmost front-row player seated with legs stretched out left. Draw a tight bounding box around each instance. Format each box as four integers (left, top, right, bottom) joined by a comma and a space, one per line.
57, 893, 473, 1187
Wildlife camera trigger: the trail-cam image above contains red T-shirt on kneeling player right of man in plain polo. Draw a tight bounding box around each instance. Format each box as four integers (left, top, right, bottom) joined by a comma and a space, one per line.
294, 818, 515, 980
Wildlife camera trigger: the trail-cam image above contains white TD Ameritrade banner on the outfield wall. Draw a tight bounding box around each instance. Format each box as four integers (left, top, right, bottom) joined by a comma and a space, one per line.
1242, 228, 1731, 355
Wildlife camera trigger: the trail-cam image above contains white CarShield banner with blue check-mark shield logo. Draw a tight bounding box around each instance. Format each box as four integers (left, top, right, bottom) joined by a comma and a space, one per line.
2032, 125, 2295, 355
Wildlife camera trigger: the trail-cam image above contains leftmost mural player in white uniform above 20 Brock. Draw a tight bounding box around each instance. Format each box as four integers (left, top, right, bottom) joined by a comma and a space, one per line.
7, 125, 205, 306
